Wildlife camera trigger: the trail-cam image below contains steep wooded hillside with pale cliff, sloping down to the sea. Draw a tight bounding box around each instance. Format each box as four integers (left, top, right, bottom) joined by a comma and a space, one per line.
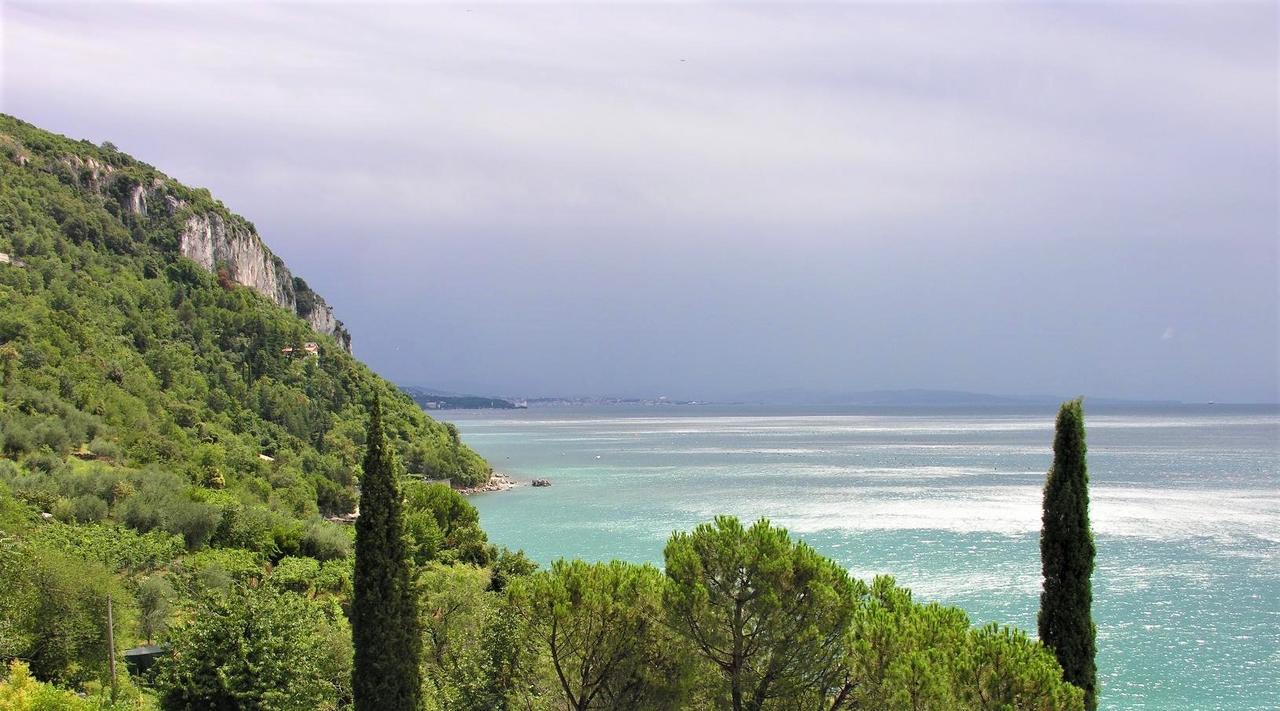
0, 114, 489, 512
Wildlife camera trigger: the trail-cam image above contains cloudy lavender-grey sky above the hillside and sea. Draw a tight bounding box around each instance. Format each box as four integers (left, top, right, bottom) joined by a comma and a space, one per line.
0, 0, 1280, 402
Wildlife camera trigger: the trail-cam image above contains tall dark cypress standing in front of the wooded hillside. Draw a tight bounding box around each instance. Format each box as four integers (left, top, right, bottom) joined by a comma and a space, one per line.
351, 397, 422, 711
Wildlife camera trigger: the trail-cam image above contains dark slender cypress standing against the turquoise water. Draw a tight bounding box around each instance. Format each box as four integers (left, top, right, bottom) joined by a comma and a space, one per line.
1038, 400, 1098, 711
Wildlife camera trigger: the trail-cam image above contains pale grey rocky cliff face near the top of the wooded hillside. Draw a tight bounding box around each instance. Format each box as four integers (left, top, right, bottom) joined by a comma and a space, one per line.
49, 155, 351, 352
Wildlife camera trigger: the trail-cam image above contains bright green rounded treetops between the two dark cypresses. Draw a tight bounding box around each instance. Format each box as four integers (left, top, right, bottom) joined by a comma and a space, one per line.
450, 518, 1083, 711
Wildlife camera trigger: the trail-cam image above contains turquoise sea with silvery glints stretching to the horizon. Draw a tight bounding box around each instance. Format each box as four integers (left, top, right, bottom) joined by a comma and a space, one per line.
448, 404, 1280, 711
